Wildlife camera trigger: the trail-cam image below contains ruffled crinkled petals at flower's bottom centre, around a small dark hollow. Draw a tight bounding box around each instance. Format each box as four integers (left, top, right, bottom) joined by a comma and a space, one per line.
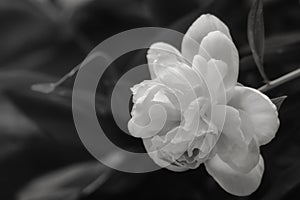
144, 98, 219, 171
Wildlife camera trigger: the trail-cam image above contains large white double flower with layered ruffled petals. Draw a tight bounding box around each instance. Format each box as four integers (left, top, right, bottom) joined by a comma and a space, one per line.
128, 14, 279, 196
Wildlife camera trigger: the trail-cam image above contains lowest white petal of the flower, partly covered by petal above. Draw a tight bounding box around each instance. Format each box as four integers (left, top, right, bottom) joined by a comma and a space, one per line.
205, 155, 264, 196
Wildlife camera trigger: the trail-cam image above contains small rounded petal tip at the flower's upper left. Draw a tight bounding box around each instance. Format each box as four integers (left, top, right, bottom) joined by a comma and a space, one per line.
147, 42, 181, 79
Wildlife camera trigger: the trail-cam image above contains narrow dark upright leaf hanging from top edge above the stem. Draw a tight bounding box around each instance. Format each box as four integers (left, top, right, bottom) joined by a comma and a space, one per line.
247, 0, 269, 82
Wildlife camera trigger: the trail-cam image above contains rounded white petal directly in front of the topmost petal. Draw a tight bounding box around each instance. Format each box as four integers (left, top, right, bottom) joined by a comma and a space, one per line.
199, 31, 239, 90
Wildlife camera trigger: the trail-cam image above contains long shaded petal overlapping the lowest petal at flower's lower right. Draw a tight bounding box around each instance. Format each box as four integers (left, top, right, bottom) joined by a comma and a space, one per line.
213, 105, 259, 173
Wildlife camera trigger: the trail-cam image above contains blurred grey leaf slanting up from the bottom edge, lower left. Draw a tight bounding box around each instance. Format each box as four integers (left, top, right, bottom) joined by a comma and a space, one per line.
18, 162, 110, 200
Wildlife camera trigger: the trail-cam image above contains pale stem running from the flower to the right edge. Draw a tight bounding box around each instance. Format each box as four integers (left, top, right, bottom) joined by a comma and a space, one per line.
258, 68, 300, 92
